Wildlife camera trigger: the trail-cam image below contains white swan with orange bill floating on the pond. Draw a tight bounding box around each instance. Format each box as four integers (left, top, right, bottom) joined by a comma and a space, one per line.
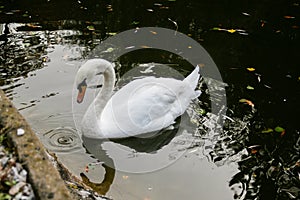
75, 59, 201, 138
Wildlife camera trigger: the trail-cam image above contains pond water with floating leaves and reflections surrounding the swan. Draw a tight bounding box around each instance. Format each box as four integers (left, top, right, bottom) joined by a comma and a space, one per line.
0, 0, 300, 199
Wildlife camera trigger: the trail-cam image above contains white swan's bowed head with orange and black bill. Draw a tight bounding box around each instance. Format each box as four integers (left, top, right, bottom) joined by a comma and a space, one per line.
75, 58, 113, 103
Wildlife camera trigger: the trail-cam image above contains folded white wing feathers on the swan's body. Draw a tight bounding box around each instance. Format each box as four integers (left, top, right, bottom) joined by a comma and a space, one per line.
100, 77, 189, 138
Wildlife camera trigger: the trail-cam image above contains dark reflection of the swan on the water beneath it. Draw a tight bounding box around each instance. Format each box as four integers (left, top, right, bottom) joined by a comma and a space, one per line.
80, 115, 189, 195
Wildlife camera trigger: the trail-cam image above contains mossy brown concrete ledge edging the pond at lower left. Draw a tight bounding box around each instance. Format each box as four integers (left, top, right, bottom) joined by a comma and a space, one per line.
0, 90, 74, 200
